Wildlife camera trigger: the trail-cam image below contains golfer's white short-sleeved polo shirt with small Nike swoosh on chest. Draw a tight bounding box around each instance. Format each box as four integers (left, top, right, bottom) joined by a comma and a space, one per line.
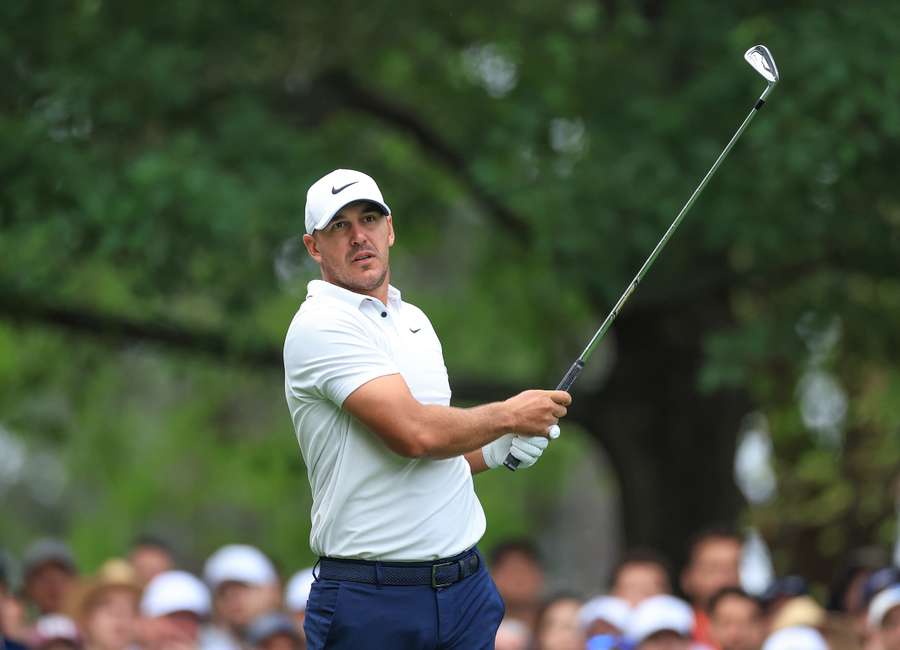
284, 280, 485, 561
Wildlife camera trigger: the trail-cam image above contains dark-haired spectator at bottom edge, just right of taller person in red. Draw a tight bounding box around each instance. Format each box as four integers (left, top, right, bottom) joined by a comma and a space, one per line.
709, 587, 765, 650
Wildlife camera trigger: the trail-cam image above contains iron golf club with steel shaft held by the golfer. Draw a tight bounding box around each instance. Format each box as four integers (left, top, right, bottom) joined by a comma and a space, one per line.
503, 45, 779, 471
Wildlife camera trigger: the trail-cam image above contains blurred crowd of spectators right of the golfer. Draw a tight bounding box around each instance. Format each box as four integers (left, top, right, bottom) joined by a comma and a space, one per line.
491, 529, 900, 650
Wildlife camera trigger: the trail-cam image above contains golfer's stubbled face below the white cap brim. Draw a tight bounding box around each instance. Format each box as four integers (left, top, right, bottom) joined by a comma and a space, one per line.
303, 201, 394, 294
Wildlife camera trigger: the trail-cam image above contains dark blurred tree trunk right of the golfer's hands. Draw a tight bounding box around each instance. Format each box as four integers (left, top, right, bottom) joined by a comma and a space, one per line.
572, 284, 749, 577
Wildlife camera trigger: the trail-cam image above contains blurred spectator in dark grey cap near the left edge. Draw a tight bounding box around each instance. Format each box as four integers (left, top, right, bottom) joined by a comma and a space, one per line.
23, 538, 78, 615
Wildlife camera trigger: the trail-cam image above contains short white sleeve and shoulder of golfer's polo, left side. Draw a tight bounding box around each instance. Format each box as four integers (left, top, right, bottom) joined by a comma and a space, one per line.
284, 310, 400, 406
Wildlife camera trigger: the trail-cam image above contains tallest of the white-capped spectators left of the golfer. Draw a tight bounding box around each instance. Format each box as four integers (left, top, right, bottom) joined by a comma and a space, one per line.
202, 544, 281, 650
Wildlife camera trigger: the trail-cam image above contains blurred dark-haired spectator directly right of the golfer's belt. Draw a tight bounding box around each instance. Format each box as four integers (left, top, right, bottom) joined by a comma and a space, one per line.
490, 539, 544, 629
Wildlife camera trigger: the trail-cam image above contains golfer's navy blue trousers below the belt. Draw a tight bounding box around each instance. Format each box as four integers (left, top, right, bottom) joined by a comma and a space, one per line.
303, 548, 505, 650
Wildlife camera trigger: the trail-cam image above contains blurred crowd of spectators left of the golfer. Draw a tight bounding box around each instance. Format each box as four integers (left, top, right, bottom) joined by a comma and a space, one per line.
0, 537, 314, 650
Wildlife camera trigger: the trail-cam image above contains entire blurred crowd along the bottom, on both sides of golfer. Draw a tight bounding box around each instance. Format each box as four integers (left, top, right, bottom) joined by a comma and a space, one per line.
0, 529, 900, 650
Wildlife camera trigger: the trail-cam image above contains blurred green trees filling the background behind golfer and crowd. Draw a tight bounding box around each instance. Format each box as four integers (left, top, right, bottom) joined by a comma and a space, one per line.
0, 0, 900, 612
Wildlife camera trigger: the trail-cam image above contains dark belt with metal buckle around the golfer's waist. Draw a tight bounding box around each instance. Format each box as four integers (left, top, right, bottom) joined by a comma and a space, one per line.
316, 547, 481, 589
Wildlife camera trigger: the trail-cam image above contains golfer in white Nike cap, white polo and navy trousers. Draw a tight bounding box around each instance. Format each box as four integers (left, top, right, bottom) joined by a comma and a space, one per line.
284, 169, 571, 650
